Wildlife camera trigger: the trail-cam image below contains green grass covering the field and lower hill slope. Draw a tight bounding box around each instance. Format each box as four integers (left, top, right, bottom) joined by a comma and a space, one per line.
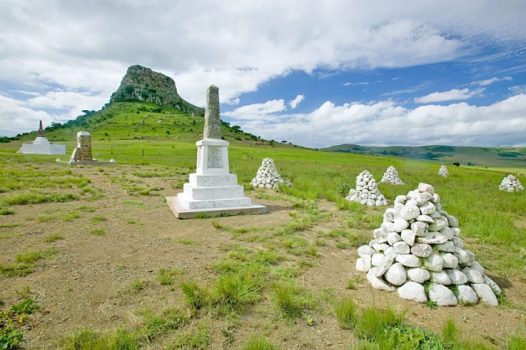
0, 100, 526, 349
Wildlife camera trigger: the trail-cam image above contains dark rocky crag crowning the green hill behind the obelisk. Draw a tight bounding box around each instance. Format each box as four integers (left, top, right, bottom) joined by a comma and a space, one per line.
110, 65, 204, 115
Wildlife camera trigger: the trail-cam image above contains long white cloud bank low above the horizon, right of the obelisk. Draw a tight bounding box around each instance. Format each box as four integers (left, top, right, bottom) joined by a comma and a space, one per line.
233, 94, 526, 147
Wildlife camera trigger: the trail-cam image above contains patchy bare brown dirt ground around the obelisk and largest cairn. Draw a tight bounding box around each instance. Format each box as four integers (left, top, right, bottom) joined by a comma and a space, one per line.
0, 164, 526, 349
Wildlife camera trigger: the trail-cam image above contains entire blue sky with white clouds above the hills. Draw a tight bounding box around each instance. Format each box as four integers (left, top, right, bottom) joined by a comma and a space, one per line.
0, 0, 526, 147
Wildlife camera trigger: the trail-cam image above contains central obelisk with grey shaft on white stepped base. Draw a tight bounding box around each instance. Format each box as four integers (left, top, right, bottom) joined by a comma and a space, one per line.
166, 85, 267, 219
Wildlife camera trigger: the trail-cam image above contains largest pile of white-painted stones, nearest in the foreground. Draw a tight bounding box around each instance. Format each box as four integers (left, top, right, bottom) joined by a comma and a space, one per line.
356, 183, 501, 306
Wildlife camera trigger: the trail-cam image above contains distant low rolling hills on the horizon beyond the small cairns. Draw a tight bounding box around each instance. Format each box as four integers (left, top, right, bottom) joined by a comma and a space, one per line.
323, 144, 526, 168
